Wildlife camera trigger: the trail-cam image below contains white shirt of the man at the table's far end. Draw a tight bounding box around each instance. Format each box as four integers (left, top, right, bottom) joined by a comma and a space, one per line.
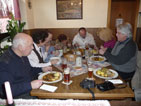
73, 32, 96, 48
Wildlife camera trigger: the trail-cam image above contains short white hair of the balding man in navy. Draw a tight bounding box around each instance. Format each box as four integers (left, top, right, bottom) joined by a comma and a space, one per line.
12, 33, 28, 48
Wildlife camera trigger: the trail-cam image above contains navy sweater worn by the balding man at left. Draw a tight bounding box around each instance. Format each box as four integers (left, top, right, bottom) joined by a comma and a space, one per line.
0, 48, 41, 98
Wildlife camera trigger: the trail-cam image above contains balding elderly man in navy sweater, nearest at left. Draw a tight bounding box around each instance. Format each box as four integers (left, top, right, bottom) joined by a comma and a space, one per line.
0, 33, 45, 98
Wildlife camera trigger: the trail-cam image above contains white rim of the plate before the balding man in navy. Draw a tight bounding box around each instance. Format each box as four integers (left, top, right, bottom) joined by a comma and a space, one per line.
38, 71, 63, 83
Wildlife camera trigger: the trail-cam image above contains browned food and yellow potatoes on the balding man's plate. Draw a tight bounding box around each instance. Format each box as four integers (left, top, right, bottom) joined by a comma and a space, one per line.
43, 72, 60, 82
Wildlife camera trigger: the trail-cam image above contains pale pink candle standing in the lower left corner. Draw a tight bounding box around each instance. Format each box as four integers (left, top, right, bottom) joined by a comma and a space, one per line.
4, 81, 15, 106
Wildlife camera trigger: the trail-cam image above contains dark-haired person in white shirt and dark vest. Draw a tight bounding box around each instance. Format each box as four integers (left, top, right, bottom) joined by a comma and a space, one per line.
28, 31, 56, 70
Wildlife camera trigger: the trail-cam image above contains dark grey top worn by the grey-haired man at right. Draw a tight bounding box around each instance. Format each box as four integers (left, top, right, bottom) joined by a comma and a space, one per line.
104, 38, 138, 73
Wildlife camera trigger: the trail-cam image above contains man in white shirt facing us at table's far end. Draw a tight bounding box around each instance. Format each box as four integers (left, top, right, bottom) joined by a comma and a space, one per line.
73, 27, 96, 48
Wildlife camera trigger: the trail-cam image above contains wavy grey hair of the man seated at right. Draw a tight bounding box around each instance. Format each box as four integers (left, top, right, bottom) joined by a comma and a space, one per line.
117, 22, 132, 38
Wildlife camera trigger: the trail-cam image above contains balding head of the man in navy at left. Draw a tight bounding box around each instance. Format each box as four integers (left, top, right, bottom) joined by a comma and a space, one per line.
12, 33, 33, 56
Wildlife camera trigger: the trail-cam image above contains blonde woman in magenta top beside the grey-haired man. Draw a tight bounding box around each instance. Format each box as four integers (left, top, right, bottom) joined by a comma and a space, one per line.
98, 28, 116, 48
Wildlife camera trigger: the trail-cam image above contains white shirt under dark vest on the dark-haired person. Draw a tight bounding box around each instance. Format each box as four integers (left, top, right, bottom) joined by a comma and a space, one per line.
28, 43, 51, 67
